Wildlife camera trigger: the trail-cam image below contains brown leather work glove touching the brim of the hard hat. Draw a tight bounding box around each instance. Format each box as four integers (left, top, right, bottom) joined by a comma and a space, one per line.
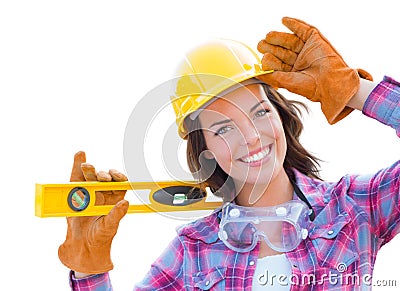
257, 17, 372, 124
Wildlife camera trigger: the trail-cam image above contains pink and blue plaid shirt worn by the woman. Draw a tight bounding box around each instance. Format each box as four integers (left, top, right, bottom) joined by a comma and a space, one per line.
70, 77, 400, 291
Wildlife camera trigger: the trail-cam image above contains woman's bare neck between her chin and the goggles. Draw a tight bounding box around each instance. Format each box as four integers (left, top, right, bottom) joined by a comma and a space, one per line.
235, 168, 294, 207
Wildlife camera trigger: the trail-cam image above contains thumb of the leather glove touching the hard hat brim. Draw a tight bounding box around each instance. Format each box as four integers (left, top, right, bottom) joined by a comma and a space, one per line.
257, 71, 316, 98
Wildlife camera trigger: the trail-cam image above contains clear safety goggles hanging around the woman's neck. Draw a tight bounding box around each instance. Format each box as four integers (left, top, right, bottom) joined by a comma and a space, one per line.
218, 200, 312, 252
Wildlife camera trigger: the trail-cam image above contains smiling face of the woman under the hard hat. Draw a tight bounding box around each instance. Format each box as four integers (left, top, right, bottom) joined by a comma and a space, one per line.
199, 84, 286, 191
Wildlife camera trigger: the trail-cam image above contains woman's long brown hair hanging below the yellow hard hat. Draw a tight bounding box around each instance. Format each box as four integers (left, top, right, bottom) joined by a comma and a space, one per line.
185, 84, 321, 200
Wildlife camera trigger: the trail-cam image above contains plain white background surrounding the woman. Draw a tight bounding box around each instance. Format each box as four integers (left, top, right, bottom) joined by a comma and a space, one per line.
0, 0, 400, 290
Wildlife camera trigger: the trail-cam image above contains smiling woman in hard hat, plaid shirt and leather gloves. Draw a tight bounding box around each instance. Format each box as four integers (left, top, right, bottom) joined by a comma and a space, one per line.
59, 18, 400, 290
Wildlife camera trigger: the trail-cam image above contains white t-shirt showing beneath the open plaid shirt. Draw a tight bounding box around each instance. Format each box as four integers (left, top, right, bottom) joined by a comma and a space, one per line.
252, 254, 292, 291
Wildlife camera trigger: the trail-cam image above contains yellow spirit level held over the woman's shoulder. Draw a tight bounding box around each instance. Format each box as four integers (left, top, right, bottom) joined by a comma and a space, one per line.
35, 181, 221, 217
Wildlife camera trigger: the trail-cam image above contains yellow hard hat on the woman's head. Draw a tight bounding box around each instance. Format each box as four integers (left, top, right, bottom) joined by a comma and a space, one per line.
171, 39, 272, 139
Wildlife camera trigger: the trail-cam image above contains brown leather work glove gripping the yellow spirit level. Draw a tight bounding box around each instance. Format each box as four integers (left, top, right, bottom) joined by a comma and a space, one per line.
58, 152, 129, 274
